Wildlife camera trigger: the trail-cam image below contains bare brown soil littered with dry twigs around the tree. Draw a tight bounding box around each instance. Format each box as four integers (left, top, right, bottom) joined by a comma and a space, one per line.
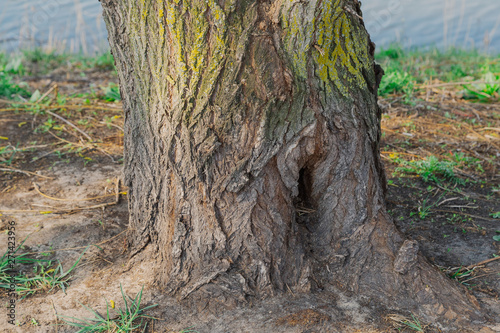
0, 69, 500, 333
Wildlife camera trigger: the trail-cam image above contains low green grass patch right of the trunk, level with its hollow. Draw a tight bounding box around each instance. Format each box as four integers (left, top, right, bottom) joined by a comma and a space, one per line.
392, 156, 465, 185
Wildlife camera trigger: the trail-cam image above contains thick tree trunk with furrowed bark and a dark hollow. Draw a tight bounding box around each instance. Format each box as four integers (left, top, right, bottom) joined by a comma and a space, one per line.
101, 0, 484, 319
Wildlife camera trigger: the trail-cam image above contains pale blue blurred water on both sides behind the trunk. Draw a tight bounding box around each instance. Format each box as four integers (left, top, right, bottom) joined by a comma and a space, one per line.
0, 0, 500, 55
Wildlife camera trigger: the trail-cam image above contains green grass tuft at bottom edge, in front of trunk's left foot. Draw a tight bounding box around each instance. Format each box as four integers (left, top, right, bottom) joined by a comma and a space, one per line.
60, 285, 158, 333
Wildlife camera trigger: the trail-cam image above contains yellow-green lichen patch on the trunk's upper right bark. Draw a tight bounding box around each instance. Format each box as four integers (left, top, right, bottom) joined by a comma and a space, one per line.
282, 0, 371, 97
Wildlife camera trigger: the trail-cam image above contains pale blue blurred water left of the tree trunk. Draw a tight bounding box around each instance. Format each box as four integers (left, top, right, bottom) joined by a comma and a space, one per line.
0, 0, 108, 55
